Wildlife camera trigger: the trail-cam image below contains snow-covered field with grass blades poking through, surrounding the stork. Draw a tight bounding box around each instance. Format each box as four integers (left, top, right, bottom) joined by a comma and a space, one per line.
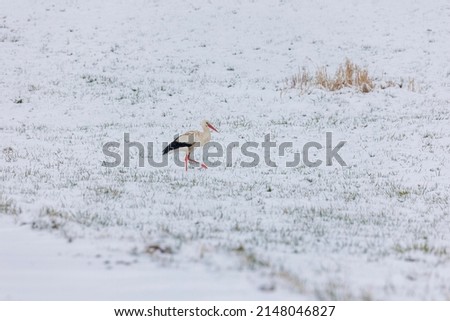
0, 0, 450, 300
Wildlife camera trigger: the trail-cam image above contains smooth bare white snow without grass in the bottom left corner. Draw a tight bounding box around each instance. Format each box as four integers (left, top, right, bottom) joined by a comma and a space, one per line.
0, 218, 286, 300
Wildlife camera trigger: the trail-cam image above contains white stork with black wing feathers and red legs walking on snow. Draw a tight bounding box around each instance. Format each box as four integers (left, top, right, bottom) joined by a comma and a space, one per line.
163, 120, 218, 171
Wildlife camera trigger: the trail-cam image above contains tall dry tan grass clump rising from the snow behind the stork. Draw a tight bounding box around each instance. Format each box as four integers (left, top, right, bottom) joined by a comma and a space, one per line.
285, 59, 417, 94
